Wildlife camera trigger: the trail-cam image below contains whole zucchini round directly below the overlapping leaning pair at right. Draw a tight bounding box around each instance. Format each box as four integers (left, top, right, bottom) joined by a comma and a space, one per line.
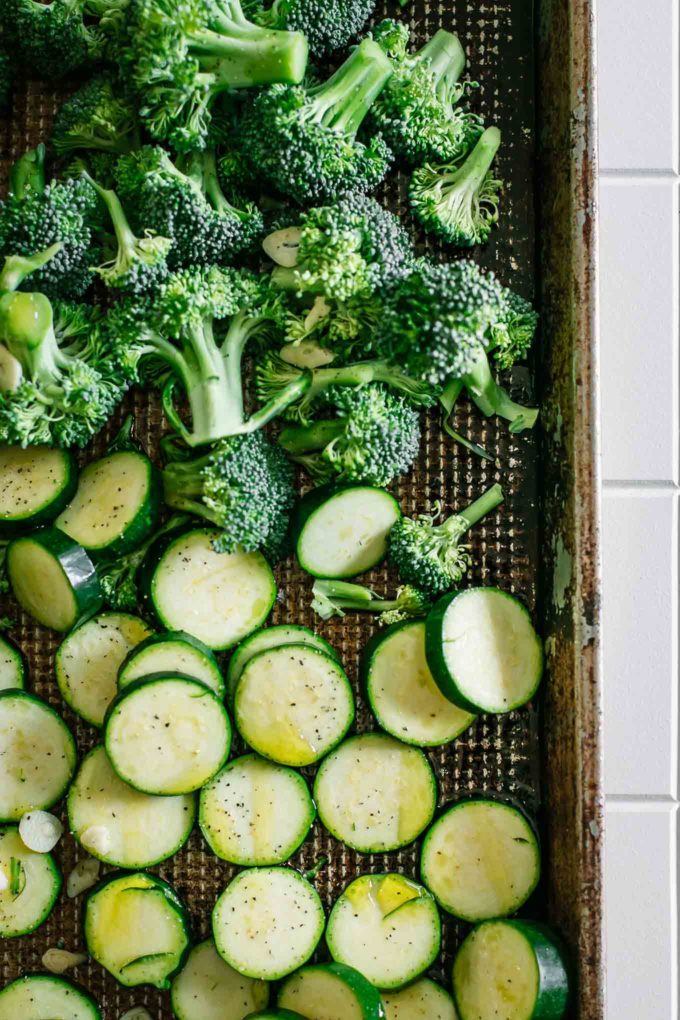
314, 733, 436, 854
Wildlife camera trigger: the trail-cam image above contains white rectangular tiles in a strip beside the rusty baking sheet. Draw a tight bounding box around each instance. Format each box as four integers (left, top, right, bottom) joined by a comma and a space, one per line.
597, 0, 680, 1020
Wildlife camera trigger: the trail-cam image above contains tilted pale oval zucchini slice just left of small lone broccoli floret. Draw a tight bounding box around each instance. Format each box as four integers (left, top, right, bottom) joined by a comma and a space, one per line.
292, 486, 402, 578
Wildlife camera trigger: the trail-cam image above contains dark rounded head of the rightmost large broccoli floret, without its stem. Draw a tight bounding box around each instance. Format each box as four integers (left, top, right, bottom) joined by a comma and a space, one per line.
373, 261, 504, 386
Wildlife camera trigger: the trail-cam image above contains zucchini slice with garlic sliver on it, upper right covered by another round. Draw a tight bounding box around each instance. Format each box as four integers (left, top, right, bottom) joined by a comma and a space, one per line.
66, 746, 196, 869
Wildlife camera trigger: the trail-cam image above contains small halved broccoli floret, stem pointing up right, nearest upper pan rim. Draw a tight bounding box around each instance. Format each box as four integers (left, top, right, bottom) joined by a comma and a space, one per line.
410, 128, 503, 248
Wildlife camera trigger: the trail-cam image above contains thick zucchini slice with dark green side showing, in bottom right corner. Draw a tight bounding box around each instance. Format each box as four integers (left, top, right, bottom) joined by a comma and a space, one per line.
454, 920, 569, 1020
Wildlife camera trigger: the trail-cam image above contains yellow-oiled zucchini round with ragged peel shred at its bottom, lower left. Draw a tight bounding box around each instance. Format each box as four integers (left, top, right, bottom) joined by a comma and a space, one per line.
85, 871, 190, 988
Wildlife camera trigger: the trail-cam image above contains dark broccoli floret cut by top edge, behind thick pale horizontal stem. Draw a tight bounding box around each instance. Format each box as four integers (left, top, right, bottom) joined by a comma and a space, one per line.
253, 0, 375, 57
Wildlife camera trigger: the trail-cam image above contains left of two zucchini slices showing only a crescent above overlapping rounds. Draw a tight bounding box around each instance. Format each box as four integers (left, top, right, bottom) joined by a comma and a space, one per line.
118, 630, 224, 698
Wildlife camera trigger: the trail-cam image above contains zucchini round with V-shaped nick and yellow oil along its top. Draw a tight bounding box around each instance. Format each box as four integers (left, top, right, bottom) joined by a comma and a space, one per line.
326, 874, 441, 988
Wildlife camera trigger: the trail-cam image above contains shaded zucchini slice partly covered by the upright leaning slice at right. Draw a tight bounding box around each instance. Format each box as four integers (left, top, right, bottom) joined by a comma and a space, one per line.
362, 620, 476, 748
